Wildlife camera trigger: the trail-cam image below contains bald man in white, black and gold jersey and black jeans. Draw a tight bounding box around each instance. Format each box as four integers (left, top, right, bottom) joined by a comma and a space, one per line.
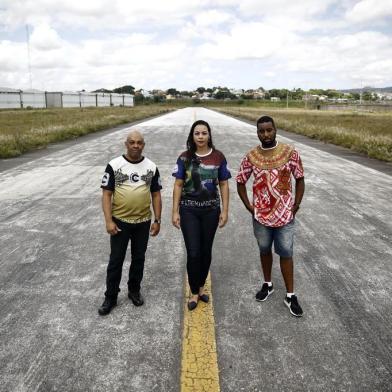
98, 131, 162, 315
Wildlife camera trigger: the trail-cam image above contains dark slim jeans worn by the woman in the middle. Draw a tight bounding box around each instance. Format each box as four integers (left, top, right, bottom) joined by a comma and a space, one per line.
180, 207, 220, 294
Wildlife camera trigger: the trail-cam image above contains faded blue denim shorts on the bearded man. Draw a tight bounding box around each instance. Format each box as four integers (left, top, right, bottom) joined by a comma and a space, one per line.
253, 218, 295, 257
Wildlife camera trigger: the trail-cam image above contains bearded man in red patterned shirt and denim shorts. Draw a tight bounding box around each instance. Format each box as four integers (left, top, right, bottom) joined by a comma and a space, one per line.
236, 116, 305, 317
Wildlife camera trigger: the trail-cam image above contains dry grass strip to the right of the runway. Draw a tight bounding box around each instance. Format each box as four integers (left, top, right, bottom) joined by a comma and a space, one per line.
215, 106, 392, 162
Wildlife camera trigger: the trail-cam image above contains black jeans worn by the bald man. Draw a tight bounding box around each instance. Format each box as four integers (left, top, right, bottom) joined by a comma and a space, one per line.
105, 218, 151, 299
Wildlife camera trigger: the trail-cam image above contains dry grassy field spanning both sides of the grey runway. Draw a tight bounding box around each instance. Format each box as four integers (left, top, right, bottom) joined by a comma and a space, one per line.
0, 99, 392, 162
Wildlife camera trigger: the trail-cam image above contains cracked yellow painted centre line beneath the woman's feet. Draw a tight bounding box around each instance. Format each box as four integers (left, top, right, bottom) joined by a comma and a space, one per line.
181, 276, 220, 392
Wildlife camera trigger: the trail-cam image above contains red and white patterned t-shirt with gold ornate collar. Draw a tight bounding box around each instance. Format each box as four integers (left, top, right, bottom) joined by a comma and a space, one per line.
236, 143, 304, 227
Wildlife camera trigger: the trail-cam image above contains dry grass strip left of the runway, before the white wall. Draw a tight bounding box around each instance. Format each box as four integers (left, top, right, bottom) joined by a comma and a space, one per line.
0, 105, 173, 158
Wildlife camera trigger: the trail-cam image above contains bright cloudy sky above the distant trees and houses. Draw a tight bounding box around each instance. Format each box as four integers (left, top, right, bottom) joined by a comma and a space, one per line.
0, 0, 392, 91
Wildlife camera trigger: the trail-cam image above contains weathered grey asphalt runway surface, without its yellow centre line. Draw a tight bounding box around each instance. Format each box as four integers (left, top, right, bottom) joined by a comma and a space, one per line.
0, 108, 392, 392
